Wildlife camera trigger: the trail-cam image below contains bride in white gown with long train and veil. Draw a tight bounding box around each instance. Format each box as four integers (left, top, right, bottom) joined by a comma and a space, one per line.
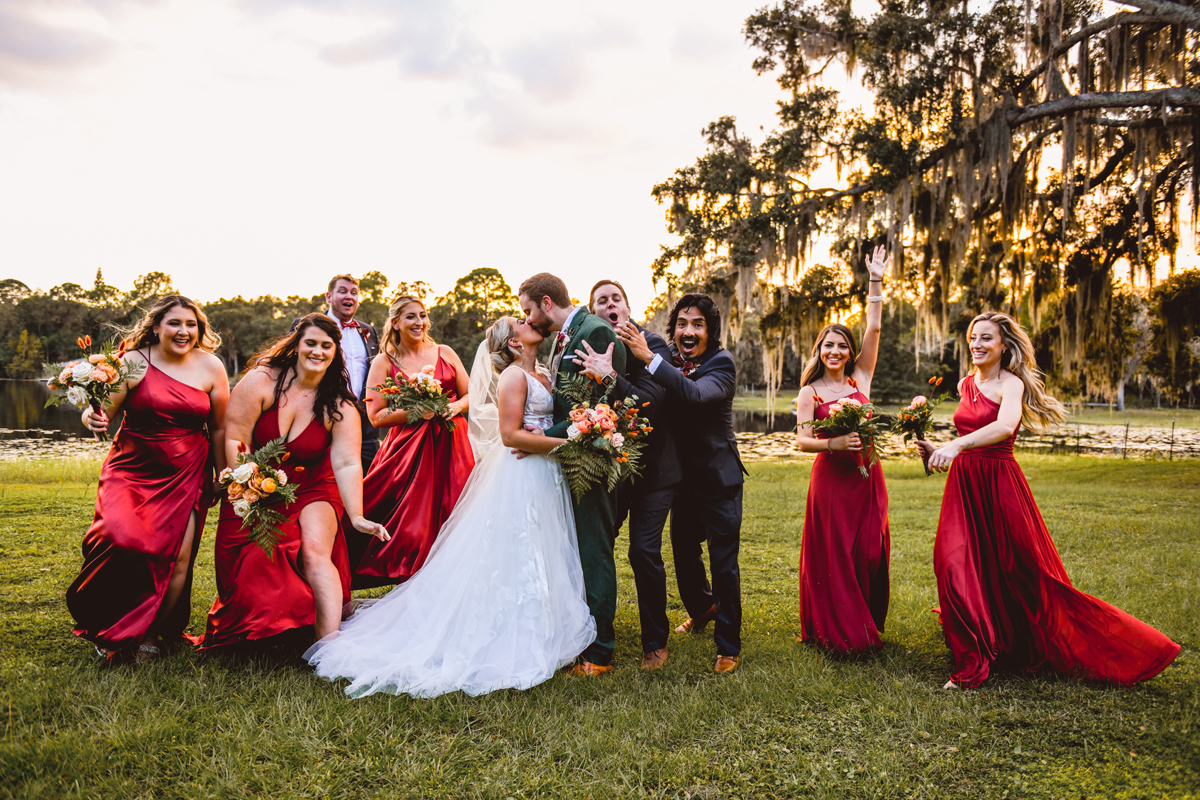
305, 317, 595, 697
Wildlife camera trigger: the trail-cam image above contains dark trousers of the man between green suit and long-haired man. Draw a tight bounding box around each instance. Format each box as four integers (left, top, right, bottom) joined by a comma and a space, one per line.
617, 483, 674, 652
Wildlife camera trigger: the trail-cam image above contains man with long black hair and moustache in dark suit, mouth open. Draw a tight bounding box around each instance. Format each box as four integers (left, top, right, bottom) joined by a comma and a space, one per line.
617, 294, 745, 673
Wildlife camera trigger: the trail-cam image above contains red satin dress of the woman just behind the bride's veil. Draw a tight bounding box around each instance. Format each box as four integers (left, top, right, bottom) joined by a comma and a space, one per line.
342, 355, 475, 589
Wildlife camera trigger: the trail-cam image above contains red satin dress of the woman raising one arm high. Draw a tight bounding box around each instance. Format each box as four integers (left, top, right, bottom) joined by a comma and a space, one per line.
800, 391, 892, 654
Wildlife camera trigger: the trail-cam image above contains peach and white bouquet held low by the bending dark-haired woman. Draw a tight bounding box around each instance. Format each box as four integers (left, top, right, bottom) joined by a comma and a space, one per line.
220, 437, 304, 558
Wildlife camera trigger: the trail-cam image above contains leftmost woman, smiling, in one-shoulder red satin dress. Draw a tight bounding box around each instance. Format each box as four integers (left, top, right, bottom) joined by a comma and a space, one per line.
67, 295, 229, 662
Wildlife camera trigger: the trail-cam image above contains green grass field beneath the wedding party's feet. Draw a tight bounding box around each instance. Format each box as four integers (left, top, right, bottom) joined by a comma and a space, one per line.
0, 456, 1200, 799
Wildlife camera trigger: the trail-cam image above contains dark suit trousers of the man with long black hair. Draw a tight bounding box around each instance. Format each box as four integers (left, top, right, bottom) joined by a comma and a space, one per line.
671, 481, 742, 656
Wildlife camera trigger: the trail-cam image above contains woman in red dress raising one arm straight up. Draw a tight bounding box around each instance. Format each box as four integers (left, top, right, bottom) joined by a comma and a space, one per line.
796, 247, 892, 654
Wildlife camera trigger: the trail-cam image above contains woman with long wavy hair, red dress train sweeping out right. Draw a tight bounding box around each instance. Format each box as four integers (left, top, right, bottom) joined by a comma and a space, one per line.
919, 312, 1180, 688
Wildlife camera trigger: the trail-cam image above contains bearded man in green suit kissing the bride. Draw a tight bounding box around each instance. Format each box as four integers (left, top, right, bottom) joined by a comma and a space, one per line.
518, 272, 625, 675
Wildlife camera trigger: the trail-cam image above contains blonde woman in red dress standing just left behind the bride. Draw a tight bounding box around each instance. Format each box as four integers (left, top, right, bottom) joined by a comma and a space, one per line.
347, 295, 475, 589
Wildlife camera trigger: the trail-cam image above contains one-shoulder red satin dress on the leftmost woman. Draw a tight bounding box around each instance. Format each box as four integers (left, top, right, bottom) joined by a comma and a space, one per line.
67, 365, 212, 650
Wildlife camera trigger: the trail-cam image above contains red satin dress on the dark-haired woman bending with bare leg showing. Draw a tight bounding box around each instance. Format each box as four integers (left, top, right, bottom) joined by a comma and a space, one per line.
202, 405, 350, 649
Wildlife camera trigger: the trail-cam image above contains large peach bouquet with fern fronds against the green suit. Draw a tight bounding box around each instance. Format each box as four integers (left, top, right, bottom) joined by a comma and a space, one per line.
552, 375, 654, 500
